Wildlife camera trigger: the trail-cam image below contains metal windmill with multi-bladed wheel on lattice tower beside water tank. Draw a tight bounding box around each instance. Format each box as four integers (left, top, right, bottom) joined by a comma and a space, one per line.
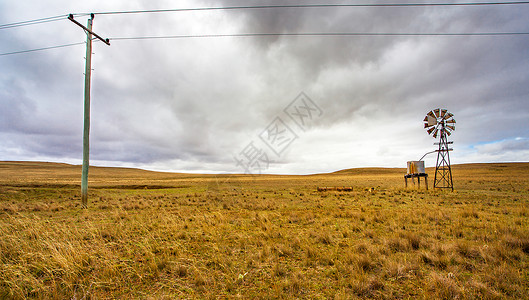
424, 108, 456, 191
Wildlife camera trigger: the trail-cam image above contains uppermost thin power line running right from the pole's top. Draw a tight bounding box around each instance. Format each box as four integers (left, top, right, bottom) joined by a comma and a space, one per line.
86, 1, 529, 15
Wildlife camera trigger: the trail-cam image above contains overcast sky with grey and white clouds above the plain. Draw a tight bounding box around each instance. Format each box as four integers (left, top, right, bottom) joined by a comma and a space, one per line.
0, 0, 529, 174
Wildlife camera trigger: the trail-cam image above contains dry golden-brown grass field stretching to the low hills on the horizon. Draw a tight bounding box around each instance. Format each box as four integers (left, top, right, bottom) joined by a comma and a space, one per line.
0, 162, 529, 299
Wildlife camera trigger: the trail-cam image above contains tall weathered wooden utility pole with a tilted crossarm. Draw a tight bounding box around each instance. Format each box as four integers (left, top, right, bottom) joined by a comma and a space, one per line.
68, 14, 110, 208
